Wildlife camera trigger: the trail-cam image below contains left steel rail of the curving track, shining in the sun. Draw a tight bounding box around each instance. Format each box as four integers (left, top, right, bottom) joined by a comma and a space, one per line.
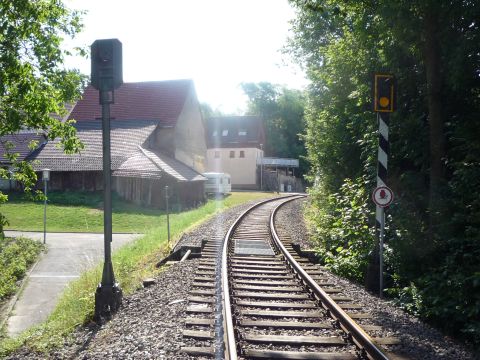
221, 195, 296, 360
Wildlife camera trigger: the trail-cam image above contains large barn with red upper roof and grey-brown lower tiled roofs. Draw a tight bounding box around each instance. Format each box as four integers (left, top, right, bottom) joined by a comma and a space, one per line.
29, 80, 206, 206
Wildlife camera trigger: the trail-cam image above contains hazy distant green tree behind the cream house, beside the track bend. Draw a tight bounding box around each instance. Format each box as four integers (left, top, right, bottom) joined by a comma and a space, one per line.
242, 82, 307, 175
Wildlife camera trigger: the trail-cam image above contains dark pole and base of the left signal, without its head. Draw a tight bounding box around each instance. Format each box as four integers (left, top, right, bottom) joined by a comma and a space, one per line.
95, 91, 122, 319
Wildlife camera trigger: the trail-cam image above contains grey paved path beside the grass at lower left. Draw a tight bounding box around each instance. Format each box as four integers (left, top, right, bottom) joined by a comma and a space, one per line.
5, 231, 139, 336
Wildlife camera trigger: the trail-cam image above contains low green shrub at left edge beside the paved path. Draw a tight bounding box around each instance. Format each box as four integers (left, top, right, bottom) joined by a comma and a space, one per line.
0, 238, 43, 301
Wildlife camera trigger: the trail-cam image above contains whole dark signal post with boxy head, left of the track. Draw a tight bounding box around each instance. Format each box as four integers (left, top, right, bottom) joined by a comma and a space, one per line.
91, 39, 123, 321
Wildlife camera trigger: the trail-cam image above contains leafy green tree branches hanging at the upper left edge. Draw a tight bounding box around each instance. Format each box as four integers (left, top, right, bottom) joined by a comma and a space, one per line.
0, 0, 84, 236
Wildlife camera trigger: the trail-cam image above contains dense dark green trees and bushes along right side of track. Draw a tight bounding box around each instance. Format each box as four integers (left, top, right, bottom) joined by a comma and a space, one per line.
286, 0, 480, 345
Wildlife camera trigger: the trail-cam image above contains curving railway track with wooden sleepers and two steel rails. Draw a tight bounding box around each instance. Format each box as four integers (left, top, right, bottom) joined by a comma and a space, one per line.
182, 196, 397, 360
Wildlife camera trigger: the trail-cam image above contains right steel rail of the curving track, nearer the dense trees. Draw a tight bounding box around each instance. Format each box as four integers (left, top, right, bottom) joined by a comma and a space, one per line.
270, 199, 389, 360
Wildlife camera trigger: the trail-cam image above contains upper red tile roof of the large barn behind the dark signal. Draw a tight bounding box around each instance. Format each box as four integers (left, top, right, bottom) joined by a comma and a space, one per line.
69, 80, 193, 126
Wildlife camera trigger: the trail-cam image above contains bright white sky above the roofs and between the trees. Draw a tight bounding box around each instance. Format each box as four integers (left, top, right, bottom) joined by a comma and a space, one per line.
65, 0, 308, 115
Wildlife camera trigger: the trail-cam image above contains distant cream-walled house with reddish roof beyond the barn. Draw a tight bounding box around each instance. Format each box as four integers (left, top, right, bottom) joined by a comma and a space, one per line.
207, 116, 265, 189
